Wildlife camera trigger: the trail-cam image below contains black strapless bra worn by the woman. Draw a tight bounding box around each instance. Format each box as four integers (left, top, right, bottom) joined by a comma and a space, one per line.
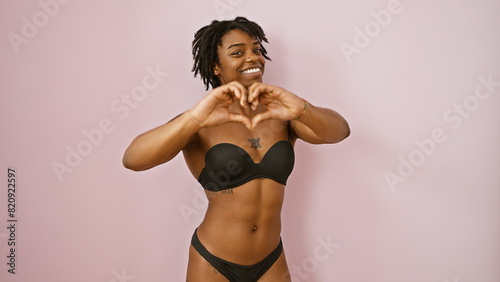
198, 140, 295, 192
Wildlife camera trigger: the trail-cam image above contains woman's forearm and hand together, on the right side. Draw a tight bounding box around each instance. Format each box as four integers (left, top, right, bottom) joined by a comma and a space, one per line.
248, 83, 350, 144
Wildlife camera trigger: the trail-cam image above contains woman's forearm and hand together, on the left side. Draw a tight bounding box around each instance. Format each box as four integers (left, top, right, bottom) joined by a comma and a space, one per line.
123, 82, 250, 171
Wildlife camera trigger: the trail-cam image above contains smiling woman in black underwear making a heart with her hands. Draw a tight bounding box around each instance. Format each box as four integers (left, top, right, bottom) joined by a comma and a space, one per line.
123, 17, 349, 282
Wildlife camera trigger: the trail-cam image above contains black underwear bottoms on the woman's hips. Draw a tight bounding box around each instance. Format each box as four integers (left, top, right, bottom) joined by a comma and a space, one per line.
191, 230, 283, 282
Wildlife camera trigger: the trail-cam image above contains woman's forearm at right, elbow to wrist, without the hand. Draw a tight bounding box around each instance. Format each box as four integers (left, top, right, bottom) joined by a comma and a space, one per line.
291, 102, 350, 144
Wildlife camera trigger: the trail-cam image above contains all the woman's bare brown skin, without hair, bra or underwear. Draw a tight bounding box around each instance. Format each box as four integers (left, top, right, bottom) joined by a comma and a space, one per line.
123, 29, 349, 282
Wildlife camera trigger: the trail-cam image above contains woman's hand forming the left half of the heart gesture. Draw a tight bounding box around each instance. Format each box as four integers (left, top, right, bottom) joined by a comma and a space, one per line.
190, 81, 252, 129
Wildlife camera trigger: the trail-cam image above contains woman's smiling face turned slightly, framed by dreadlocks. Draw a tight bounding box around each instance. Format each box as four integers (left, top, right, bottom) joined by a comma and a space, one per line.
214, 29, 266, 88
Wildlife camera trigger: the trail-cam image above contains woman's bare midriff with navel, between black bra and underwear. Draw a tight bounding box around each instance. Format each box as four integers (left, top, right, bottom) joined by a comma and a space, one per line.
197, 179, 285, 265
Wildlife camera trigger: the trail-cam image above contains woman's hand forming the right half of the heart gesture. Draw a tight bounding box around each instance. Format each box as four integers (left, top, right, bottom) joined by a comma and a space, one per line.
248, 83, 305, 128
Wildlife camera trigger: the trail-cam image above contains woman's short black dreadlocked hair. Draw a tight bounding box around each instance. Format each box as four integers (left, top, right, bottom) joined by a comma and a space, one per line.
192, 17, 271, 90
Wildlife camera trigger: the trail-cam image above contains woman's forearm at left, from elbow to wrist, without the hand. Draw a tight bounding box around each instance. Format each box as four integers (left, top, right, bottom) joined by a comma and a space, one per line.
123, 111, 201, 171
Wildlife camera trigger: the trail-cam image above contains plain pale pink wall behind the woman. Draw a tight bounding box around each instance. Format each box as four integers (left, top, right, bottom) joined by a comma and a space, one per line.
0, 0, 500, 282
